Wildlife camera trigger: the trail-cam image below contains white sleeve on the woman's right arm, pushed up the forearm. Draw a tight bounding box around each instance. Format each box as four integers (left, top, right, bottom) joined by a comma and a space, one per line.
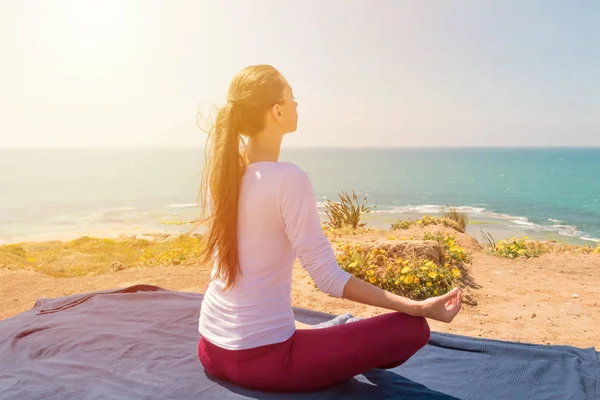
279, 164, 351, 297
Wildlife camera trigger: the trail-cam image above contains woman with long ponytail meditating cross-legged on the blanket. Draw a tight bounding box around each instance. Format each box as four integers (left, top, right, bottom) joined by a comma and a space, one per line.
198, 65, 461, 391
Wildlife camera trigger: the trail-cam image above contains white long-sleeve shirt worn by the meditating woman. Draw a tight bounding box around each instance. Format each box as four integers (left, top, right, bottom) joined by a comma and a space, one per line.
199, 162, 351, 350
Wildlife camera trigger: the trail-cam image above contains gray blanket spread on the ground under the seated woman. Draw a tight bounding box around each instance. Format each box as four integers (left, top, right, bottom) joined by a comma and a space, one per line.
0, 285, 600, 400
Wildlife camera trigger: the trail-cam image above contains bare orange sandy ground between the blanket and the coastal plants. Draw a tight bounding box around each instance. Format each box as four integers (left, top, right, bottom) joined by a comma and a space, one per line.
0, 231, 600, 348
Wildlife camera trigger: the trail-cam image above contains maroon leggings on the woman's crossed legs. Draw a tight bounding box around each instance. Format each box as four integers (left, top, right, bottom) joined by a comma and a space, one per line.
198, 312, 429, 392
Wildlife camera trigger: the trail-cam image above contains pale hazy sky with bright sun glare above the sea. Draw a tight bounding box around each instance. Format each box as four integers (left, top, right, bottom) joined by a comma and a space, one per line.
0, 0, 600, 147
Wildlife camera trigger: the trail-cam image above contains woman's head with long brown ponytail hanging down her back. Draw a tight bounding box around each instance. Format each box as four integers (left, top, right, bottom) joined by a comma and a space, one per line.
200, 65, 298, 288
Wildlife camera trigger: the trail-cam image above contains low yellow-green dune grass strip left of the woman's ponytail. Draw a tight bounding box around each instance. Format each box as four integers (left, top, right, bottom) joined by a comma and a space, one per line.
0, 235, 203, 277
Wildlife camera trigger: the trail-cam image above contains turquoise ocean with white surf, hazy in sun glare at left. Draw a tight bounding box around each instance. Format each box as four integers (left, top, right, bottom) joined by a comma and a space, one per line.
0, 148, 600, 245
